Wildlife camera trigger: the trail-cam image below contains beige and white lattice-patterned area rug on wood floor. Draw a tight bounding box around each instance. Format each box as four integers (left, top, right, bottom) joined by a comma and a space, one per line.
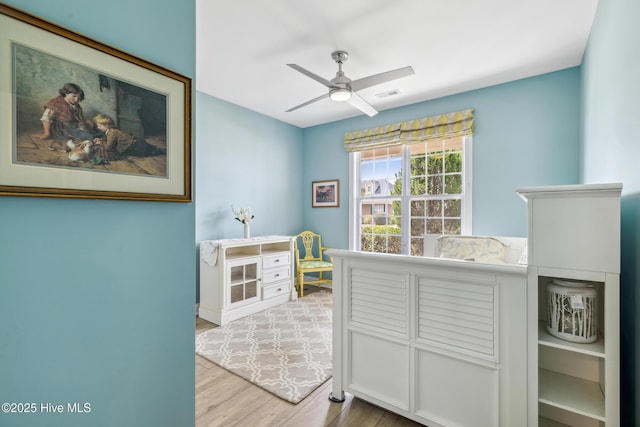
196, 291, 333, 403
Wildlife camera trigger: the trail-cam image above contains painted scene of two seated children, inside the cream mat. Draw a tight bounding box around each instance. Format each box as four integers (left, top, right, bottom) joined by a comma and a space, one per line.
12, 45, 168, 177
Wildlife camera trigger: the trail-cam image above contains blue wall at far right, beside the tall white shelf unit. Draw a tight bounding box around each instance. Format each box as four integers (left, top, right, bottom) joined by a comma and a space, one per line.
582, 0, 640, 426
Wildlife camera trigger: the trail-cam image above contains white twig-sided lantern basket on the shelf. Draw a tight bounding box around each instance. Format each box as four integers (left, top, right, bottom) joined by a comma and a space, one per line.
547, 279, 598, 343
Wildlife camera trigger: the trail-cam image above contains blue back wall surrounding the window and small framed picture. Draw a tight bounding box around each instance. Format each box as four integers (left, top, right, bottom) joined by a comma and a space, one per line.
302, 68, 580, 248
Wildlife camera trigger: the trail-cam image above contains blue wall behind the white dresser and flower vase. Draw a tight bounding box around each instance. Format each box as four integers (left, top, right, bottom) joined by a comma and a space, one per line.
196, 92, 303, 301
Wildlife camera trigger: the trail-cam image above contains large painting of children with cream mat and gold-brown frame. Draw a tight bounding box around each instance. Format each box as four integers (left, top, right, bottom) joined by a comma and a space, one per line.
0, 4, 192, 202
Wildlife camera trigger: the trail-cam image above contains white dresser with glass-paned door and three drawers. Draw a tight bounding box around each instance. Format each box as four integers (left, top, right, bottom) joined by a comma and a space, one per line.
198, 236, 297, 325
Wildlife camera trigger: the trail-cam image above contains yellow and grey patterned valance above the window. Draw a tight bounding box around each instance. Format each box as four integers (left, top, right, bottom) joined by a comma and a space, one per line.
344, 109, 473, 152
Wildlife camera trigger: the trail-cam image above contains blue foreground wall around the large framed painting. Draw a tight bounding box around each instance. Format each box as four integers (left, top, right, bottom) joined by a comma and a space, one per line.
0, 0, 196, 427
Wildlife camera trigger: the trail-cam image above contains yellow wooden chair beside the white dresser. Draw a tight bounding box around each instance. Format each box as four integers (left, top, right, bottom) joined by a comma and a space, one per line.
295, 231, 333, 297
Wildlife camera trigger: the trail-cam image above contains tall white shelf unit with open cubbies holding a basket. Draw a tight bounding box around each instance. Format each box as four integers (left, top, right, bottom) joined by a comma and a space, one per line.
517, 184, 622, 427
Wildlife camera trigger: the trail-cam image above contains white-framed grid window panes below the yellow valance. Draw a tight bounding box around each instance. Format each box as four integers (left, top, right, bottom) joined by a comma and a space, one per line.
351, 135, 472, 256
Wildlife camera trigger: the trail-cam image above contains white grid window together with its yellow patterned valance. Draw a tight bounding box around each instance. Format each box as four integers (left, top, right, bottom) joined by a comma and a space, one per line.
344, 109, 474, 256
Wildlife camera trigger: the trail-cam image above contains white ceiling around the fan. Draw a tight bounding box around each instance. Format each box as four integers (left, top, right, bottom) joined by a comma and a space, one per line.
196, 0, 597, 128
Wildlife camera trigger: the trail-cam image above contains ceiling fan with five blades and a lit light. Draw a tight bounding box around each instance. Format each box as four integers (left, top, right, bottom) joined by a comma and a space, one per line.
287, 50, 414, 117
